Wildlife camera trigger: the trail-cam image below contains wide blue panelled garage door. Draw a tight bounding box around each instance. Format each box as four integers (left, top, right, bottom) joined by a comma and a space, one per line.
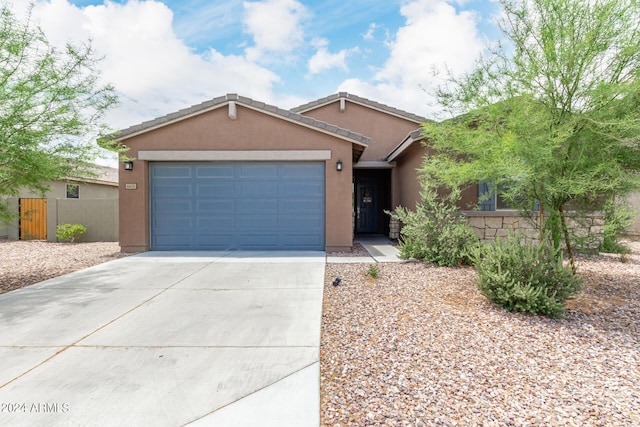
150, 162, 325, 250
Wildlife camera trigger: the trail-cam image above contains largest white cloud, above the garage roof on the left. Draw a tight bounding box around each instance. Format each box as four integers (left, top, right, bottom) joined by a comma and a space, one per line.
21, 0, 280, 128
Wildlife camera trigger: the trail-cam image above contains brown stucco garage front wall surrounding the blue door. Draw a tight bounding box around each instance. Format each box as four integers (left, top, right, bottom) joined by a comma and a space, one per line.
120, 105, 353, 251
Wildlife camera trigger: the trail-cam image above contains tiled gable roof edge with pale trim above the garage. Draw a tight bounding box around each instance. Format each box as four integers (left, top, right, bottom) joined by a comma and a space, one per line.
115, 93, 371, 151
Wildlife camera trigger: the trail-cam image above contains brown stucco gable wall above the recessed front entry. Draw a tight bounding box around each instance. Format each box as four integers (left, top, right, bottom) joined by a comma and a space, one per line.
303, 100, 420, 162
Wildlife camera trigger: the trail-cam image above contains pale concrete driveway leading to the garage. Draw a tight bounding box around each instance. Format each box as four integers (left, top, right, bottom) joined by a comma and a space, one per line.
0, 252, 325, 426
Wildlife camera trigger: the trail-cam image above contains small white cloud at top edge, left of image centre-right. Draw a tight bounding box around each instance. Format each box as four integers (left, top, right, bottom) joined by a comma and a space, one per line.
243, 0, 308, 61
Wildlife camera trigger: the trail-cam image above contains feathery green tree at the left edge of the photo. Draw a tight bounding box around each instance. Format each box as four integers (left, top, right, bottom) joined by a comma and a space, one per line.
0, 4, 117, 220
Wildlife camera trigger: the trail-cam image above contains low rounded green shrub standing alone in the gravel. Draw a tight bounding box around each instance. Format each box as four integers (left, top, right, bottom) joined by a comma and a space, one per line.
474, 234, 583, 317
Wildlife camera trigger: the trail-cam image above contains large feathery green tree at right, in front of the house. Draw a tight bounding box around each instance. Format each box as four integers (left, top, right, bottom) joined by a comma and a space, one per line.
422, 0, 640, 273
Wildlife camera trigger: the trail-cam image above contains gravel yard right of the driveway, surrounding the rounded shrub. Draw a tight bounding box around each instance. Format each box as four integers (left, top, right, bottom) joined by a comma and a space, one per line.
320, 242, 640, 426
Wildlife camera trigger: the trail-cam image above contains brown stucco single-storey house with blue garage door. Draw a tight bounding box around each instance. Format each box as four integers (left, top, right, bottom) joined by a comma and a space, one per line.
117, 92, 632, 252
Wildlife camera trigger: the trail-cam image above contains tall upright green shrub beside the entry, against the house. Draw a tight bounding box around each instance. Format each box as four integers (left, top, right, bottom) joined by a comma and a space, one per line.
391, 185, 478, 266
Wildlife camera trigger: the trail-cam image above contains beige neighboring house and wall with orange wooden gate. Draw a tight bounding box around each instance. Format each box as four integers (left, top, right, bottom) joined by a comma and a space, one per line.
0, 166, 118, 242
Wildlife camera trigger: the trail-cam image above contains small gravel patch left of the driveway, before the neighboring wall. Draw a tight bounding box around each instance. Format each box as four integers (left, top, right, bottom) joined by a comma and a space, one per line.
0, 240, 129, 294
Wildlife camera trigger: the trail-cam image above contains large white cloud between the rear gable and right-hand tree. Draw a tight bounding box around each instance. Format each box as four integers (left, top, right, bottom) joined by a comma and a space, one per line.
339, 0, 484, 116
